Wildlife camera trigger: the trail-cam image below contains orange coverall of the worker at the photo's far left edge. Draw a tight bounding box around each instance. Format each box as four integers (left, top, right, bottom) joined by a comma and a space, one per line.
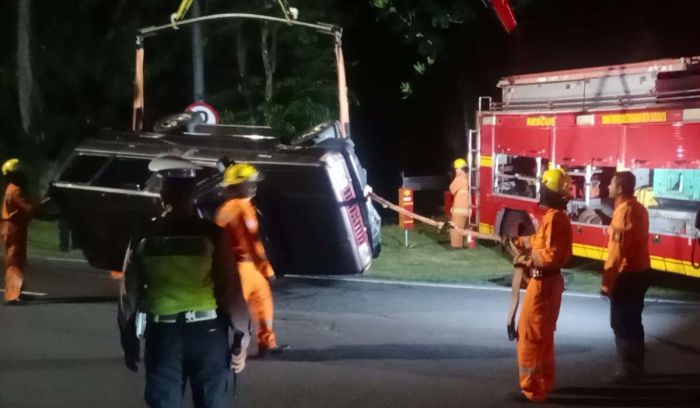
0, 183, 34, 301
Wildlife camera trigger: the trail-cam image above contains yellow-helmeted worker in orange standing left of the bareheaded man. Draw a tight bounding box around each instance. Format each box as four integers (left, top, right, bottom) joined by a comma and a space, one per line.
508, 169, 572, 402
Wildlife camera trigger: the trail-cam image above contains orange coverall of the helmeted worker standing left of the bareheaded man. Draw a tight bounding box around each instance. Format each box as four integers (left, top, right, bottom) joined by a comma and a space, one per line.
518, 208, 572, 401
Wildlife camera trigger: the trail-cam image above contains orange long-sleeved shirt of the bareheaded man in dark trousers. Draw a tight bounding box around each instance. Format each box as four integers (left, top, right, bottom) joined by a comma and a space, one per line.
601, 197, 651, 294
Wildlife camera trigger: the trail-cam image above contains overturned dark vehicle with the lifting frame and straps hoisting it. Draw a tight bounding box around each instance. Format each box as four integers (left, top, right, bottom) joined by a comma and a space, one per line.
49, 14, 380, 274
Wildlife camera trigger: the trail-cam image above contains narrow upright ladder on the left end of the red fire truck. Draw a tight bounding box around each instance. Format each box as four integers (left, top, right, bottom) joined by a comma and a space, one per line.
467, 96, 492, 231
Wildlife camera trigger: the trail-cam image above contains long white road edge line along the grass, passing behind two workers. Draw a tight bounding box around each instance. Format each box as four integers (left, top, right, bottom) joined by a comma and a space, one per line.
284, 275, 700, 305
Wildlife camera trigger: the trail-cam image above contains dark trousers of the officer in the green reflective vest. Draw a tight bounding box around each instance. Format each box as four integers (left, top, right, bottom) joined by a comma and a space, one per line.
145, 314, 232, 408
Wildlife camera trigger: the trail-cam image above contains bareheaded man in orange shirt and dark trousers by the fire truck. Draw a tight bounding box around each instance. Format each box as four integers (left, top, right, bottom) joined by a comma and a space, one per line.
600, 171, 651, 381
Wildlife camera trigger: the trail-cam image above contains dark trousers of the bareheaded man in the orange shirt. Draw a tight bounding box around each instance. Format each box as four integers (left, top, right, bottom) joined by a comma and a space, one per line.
610, 270, 651, 369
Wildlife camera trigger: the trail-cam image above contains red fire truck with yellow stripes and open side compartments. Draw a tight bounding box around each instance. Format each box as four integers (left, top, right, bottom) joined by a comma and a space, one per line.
468, 57, 700, 277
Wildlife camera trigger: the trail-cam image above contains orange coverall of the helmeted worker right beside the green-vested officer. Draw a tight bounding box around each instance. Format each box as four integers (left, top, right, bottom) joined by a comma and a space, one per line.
216, 198, 277, 349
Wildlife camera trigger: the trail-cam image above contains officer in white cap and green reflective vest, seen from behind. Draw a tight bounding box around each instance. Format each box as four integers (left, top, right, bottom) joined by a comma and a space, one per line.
118, 158, 250, 407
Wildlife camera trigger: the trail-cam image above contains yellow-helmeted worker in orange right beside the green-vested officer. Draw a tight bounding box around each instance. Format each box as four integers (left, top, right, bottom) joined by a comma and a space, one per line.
216, 163, 287, 357
